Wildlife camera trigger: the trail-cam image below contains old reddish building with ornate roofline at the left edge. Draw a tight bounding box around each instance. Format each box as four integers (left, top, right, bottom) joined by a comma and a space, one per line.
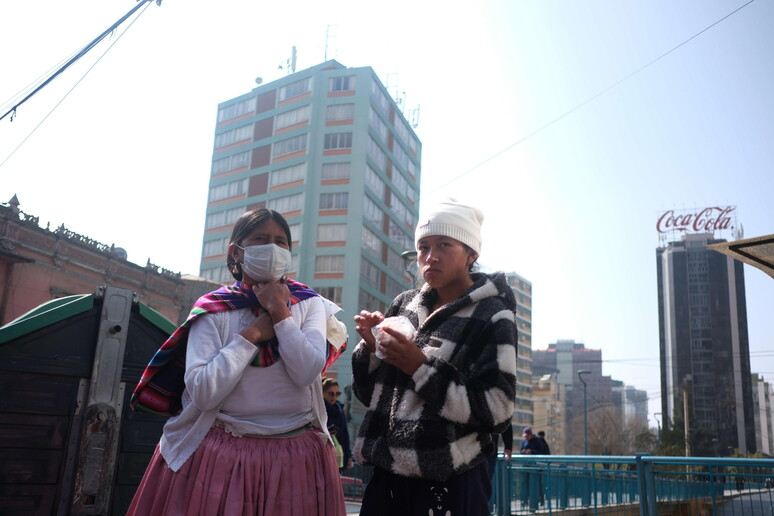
0, 203, 218, 325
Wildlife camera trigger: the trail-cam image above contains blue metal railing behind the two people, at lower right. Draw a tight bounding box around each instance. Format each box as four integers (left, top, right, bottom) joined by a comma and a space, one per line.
344, 455, 774, 516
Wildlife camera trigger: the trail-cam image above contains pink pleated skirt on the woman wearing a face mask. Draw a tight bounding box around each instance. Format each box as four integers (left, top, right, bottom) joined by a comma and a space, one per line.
127, 427, 346, 516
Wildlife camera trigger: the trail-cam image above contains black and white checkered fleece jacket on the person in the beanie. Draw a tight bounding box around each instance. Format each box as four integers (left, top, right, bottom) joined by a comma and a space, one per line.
352, 273, 517, 480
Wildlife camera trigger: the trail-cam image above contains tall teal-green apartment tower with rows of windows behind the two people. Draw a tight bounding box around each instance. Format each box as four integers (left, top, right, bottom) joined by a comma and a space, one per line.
201, 61, 422, 404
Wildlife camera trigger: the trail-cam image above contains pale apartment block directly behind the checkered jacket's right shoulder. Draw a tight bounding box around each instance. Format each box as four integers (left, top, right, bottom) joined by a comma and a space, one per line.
506, 272, 533, 435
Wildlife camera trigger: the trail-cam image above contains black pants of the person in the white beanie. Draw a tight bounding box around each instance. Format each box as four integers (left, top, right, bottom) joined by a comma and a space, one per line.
360, 461, 492, 516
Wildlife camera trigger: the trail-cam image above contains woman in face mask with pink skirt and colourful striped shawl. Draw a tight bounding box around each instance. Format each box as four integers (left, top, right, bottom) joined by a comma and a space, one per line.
128, 208, 345, 516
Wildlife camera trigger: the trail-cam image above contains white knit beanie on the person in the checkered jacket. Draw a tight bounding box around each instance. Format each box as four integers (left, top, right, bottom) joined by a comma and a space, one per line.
414, 199, 484, 254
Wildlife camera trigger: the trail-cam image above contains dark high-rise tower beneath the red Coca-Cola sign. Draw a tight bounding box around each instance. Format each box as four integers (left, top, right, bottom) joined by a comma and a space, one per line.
656, 233, 756, 456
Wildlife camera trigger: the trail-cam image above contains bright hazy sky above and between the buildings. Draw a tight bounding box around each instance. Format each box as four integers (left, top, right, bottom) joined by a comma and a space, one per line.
0, 0, 774, 425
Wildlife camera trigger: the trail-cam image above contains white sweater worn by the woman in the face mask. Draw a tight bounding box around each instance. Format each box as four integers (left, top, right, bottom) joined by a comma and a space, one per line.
159, 297, 330, 471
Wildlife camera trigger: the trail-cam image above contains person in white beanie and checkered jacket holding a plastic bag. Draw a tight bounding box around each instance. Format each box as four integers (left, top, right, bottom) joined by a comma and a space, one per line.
352, 200, 517, 516
